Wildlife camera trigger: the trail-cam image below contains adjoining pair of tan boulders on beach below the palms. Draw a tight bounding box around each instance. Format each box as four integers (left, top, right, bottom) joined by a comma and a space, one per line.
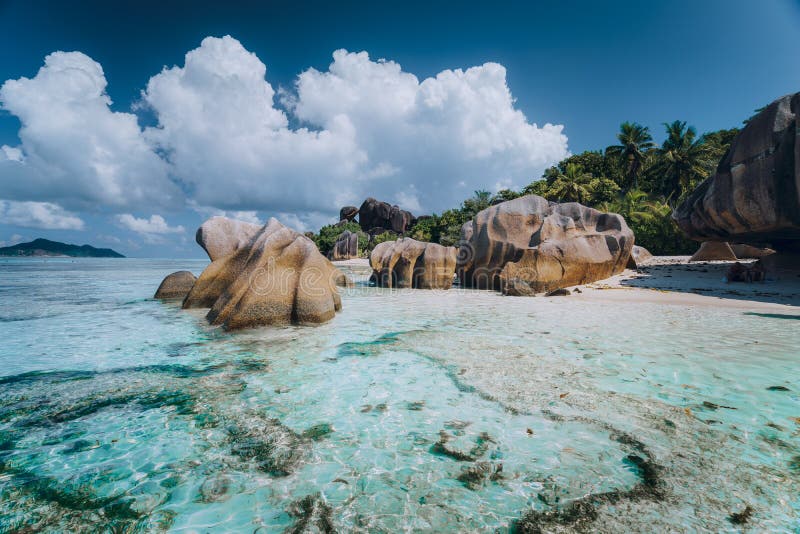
370, 195, 636, 295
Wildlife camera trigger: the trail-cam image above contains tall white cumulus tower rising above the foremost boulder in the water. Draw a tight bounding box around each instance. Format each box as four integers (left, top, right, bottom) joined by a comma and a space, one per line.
143, 37, 366, 216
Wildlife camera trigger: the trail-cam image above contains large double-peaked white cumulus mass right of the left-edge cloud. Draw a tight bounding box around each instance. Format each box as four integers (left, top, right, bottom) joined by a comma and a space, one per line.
143, 37, 568, 218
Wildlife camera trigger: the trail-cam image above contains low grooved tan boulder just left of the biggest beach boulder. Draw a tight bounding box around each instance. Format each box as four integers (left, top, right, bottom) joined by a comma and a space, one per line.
369, 237, 456, 289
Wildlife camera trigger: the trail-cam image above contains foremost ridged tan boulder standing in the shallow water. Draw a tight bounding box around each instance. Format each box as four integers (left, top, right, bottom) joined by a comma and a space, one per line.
183, 219, 346, 329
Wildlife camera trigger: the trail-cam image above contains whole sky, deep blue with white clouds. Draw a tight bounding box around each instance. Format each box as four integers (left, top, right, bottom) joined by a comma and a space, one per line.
0, 0, 800, 257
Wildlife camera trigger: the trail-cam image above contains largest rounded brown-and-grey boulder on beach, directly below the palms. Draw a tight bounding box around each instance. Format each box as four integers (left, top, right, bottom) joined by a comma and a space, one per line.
458, 195, 634, 295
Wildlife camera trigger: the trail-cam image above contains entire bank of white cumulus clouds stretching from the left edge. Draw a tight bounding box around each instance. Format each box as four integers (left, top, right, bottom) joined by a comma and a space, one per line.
0, 37, 568, 242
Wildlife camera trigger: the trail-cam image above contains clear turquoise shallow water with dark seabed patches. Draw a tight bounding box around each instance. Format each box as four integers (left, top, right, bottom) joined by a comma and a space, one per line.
0, 259, 800, 532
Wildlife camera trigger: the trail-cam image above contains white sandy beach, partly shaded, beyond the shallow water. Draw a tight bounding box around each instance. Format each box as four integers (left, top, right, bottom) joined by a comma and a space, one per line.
334, 256, 800, 315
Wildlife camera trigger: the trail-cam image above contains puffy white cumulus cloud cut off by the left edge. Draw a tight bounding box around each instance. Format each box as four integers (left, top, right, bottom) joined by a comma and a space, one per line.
0, 52, 179, 208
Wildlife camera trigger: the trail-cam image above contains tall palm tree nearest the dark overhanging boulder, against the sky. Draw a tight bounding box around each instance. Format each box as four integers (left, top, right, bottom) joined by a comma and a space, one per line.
653, 121, 712, 198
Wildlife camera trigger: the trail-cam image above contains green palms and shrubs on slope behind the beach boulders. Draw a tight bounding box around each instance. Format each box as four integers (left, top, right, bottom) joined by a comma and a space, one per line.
314, 121, 739, 255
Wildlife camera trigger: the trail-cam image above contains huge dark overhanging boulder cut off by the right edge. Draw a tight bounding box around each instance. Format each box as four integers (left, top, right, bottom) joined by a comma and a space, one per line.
673, 93, 800, 251
